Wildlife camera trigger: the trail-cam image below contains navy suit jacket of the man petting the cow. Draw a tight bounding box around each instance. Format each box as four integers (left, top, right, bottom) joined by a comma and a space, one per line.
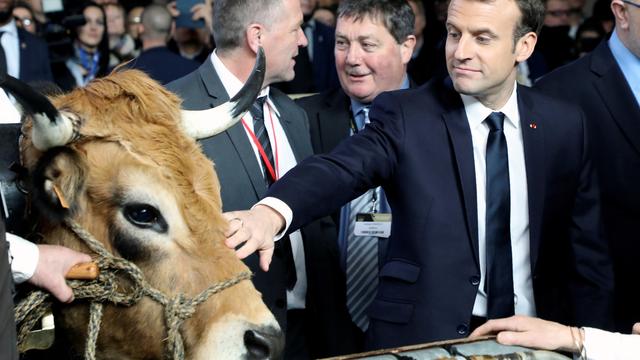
267, 79, 612, 348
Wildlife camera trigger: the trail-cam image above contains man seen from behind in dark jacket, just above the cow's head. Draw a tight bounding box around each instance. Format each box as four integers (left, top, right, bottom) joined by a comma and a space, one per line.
128, 4, 200, 84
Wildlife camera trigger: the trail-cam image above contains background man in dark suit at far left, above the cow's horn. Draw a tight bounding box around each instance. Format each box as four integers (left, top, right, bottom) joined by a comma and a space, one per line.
0, 0, 53, 82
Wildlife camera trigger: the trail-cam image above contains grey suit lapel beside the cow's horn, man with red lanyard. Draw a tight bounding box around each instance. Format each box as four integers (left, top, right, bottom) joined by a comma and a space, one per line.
198, 65, 267, 199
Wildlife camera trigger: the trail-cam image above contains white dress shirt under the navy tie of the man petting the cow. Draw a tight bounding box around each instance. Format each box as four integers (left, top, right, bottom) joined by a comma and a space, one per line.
461, 84, 536, 317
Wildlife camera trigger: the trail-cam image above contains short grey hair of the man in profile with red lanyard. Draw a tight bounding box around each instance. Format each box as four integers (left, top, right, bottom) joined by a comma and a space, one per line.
213, 0, 286, 51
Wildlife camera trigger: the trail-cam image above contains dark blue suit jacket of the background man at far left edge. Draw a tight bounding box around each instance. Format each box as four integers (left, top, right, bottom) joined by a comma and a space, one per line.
18, 28, 53, 82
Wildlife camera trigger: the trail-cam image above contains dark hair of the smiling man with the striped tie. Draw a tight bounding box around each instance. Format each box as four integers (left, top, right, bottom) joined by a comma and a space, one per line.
338, 0, 415, 44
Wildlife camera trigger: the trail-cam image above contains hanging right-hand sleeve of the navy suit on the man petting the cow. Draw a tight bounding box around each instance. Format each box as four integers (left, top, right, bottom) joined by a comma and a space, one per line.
570, 112, 614, 329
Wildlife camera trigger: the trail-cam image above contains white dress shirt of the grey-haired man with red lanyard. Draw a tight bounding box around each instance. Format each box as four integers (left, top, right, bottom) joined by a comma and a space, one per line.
211, 51, 307, 309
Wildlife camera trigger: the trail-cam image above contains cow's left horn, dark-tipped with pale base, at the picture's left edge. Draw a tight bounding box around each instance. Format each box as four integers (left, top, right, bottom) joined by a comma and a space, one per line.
0, 74, 74, 151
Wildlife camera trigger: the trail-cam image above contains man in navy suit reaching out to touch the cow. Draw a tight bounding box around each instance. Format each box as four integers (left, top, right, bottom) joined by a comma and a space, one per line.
227, 0, 613, 348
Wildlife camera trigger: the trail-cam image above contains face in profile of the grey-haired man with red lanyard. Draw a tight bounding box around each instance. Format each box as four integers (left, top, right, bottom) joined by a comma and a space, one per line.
260, 0, 307, 84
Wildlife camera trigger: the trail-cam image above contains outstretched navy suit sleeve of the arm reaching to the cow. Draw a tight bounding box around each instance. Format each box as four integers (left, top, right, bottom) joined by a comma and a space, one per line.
267, 94, 404, 231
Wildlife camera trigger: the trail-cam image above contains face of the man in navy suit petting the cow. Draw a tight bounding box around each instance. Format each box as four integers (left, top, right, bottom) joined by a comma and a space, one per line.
446, 0, 535, 105
